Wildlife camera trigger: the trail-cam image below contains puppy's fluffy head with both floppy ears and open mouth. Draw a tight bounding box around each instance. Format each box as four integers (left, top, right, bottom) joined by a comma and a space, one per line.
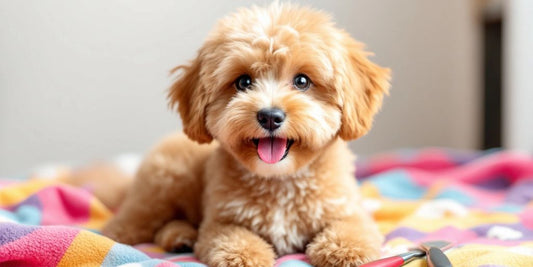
169, 4, 389, 176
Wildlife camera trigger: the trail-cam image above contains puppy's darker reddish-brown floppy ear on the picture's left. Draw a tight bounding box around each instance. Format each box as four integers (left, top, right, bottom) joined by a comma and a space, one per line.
167, 58, 213, 143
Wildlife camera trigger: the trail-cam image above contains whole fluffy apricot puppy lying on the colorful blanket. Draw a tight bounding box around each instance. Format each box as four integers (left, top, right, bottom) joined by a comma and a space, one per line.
103, 4, 389, 266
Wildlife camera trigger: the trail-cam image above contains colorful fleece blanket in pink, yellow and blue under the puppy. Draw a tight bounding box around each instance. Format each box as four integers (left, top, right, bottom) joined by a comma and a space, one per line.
0, 149, 533, 267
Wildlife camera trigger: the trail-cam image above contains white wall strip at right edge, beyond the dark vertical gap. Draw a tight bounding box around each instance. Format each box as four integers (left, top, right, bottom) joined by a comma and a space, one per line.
504, 0, 533, 152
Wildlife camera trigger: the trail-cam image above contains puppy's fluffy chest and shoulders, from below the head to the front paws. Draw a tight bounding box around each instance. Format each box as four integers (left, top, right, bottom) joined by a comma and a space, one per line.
204, 138, 360, 255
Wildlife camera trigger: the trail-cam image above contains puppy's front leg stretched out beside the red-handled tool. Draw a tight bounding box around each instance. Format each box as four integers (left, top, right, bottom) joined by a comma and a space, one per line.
306, 214, 383, 267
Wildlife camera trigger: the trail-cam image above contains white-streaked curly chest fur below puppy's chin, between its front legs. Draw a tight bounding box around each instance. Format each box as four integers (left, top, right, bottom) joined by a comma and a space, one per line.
217, 180, 352, 255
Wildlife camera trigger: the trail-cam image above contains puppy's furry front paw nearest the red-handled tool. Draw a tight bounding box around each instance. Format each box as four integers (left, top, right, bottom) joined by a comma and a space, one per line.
306, 229, 381, 267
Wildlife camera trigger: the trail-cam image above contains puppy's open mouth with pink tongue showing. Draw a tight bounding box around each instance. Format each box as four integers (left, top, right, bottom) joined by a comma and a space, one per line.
252, 136, 294, 164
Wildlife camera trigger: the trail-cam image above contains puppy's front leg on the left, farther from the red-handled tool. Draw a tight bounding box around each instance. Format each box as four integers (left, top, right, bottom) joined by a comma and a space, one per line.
194, 223, 276, 267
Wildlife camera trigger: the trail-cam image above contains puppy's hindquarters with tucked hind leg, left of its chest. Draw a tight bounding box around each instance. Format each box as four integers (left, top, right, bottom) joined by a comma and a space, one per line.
102, 134, 209, 249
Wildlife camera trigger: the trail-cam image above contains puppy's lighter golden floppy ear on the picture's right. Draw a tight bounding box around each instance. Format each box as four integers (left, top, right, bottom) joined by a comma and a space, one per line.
337, 36, 390, 140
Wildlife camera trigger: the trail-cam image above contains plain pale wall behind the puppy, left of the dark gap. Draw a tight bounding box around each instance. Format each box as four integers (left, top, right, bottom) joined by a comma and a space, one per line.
0, 0, 480, 176
